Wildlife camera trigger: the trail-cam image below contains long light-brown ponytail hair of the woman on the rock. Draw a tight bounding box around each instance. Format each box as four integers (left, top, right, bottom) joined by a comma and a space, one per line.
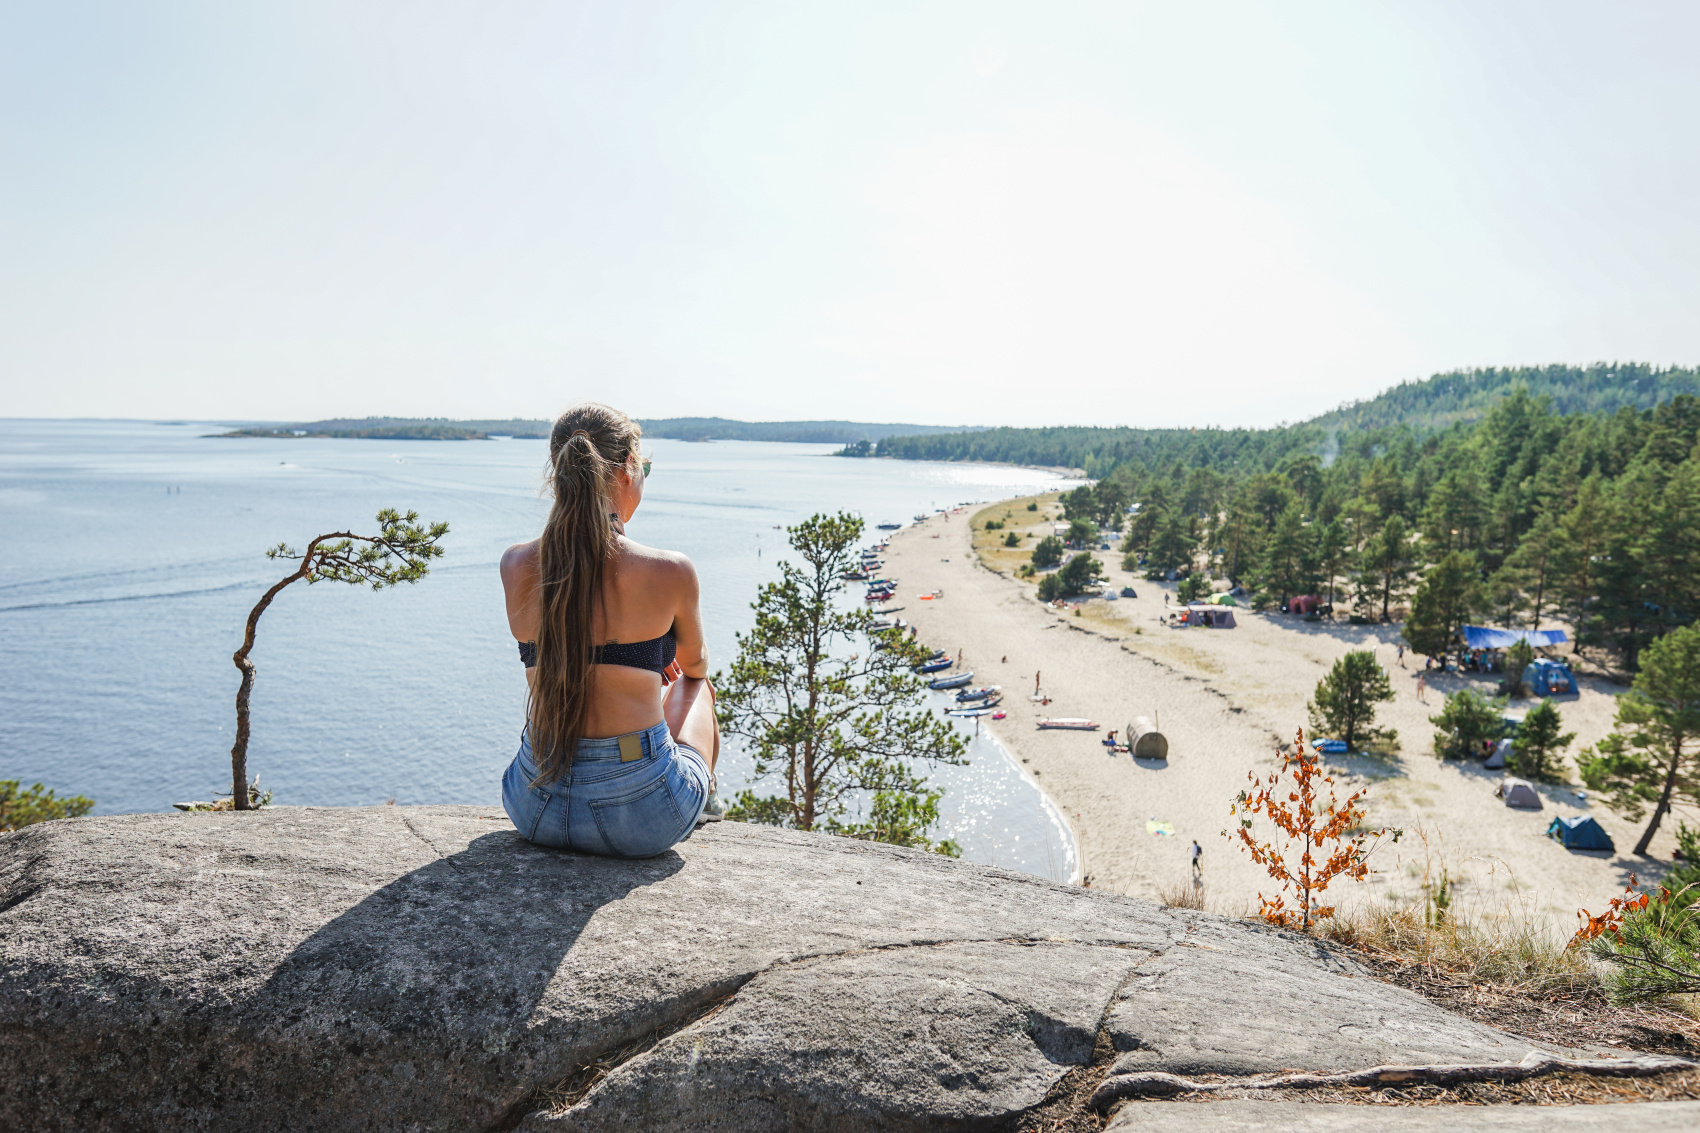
530, 401, 643, 784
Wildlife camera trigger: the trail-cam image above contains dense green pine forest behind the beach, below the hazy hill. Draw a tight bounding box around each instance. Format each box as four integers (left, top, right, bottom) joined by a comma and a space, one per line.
1064, 386, 1700, 670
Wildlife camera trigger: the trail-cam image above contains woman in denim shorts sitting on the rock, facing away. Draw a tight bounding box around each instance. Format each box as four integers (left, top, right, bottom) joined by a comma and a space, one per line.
502, 401, 724, 857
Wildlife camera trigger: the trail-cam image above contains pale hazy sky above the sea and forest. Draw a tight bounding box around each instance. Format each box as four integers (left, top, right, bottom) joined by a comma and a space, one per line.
0, 0, 1700, 425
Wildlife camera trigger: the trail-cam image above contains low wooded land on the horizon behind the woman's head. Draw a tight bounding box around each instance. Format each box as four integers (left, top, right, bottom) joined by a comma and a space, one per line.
218, 417, 984, 444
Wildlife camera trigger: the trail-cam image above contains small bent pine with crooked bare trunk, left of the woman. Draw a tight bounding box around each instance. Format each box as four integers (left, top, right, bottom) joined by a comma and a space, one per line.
230, 509, 449, 810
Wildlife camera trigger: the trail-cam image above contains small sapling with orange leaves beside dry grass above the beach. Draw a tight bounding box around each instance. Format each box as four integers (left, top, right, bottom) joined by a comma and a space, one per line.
1222, 728, 1403, 931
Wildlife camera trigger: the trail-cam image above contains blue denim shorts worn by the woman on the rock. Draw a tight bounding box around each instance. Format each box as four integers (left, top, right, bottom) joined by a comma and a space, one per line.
502, 720, 709, 857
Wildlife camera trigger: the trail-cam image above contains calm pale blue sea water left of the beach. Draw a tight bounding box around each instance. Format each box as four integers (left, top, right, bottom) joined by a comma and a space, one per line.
0, 420, 1074, 880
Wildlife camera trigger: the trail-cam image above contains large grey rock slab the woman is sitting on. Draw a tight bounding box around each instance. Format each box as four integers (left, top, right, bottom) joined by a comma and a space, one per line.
0, 806, 1584, 1130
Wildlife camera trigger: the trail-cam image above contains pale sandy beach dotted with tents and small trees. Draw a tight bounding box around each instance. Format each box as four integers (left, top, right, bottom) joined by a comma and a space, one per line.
882, 497, 1695, 932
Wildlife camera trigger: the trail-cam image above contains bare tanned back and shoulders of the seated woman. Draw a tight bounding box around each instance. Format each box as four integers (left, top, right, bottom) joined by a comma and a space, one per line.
502, 534, 709, 738
